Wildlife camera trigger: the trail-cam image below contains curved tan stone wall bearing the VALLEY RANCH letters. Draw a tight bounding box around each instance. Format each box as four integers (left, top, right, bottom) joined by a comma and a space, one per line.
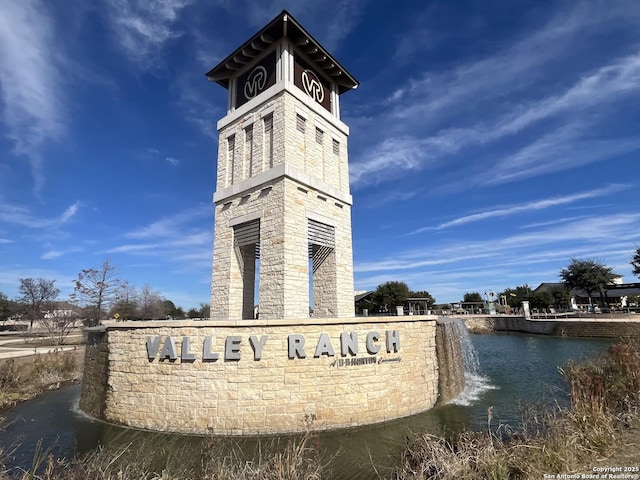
80, 316, 438, 435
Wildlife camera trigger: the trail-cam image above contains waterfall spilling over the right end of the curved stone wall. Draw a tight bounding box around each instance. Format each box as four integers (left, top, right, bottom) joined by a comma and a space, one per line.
436, 318, 486, 404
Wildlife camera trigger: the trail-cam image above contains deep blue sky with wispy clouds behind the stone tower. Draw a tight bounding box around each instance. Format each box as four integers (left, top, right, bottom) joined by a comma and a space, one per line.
0, 0, 640, 308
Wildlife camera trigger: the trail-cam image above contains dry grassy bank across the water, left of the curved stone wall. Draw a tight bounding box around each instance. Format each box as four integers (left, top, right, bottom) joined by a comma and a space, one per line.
0, 346, 84, 410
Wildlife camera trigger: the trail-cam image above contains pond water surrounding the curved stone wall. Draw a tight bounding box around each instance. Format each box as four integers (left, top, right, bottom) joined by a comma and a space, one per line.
0, 332, 611, 479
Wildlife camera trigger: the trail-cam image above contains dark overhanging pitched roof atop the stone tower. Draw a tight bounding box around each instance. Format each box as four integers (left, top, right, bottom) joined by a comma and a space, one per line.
205, 10, 359, 94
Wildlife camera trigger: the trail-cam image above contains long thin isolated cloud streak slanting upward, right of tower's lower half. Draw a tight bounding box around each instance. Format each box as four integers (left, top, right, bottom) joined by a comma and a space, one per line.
410, 185, 630, 234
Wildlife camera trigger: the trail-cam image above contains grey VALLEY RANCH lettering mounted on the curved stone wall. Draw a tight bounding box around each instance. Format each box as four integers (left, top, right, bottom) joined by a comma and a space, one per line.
146, 330, 400, 367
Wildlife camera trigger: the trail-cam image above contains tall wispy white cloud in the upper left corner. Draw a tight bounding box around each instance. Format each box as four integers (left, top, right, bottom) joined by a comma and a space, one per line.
0, 0, 67, 192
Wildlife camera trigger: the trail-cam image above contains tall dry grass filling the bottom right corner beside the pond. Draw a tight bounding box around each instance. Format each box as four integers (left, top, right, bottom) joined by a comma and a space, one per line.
395, 340, 640, 480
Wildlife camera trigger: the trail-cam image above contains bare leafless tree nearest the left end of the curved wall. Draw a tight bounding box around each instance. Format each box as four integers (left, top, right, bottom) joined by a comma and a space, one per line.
72, 260, 124, 325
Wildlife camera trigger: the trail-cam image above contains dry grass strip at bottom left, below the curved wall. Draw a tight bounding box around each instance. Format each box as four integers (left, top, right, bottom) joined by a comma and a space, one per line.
0, 432, 327, 480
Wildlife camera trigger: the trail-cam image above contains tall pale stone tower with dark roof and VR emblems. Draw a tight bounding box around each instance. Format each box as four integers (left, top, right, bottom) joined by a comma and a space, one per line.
206, 11, 358, 320
